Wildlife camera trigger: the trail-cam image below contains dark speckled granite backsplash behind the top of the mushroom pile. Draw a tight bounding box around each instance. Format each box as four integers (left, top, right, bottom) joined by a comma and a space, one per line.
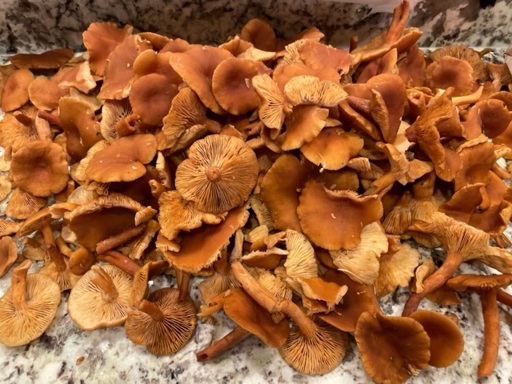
0, 0, 512, 53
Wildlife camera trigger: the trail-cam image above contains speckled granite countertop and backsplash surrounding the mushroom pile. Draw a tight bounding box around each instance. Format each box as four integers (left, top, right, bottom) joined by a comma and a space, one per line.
0, 0, 512, 384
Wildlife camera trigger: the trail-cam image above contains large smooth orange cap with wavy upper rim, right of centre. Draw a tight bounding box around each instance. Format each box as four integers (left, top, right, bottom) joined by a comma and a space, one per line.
297, 181, 383, 251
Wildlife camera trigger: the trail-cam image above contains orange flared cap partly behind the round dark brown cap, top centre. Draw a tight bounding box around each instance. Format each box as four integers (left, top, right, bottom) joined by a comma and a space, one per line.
169, 45, 233, 114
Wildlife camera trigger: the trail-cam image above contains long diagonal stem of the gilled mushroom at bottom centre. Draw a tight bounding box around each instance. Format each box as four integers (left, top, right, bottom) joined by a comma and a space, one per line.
231, 261, 317, 338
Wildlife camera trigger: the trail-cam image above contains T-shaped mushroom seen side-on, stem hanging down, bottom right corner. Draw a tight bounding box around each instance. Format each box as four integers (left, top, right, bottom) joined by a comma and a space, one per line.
447, 274, 512, 377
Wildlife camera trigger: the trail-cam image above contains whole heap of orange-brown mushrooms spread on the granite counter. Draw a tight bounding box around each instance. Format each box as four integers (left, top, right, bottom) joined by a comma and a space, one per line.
0, 0, 512, 383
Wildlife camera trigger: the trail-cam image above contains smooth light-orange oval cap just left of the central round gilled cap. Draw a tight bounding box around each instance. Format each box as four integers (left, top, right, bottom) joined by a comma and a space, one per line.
85, 134, 157, 183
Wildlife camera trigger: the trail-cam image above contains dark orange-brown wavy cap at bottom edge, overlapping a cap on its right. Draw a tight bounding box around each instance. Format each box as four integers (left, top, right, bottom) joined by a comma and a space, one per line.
354, 312, 430, 383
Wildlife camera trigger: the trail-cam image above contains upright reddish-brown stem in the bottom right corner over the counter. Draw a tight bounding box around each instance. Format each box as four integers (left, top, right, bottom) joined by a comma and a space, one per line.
478, 288, 500, 377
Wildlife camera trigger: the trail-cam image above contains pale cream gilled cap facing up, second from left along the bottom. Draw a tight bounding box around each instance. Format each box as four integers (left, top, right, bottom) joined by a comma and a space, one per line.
68, 265, 132, 331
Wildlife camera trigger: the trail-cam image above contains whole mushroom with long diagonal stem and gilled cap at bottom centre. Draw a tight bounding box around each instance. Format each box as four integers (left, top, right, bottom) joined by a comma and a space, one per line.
231, 261, 348, 375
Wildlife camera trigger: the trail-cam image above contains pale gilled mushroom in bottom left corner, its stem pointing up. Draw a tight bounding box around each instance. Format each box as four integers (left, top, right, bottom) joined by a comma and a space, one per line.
0, 260, 60, 347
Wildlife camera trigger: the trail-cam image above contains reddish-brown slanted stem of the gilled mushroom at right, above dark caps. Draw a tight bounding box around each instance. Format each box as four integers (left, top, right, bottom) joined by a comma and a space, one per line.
402, 252, 464, 316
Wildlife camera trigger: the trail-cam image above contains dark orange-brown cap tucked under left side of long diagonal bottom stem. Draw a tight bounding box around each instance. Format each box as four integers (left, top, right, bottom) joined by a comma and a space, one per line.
223, 288, 290, 348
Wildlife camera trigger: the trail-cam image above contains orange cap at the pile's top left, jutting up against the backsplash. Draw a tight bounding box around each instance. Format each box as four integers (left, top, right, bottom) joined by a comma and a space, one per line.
82, 22, 133, 76
